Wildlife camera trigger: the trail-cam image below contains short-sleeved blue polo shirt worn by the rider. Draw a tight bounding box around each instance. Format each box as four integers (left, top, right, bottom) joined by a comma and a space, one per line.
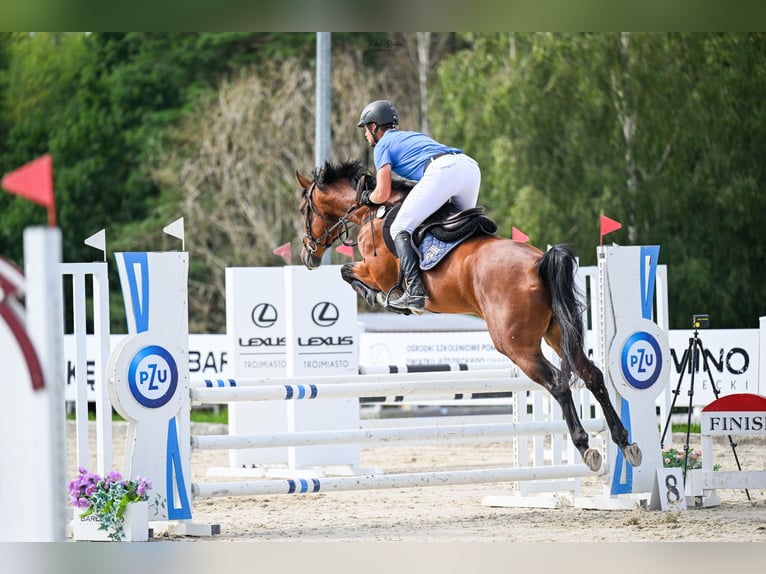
373, 130, 463, 181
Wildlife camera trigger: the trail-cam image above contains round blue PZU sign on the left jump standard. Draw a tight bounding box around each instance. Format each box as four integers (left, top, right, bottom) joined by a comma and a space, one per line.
128, 345, 178, 409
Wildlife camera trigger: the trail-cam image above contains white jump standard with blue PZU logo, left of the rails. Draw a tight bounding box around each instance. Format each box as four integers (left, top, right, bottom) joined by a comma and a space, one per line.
107, 252, 191, 520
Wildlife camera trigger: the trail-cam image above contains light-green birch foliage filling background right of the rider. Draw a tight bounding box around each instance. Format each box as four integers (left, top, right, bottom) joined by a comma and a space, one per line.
431, 34, 766, 328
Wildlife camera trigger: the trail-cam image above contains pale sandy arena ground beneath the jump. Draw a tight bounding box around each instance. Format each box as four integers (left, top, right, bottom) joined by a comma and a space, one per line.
67, 422, 766, 542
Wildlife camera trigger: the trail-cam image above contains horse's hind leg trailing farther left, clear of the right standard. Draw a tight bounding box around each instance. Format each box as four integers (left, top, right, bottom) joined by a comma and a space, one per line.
512, 351, 601, 472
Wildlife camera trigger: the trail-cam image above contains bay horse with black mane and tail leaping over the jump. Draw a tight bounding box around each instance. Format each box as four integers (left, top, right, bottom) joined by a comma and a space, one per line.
295, 161, 642, 472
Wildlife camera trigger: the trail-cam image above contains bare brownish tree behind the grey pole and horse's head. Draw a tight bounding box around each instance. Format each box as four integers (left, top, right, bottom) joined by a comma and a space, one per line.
154, 51, 417, 333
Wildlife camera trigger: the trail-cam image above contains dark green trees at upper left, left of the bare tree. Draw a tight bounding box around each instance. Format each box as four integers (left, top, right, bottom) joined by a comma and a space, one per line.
0, 33, 336, 331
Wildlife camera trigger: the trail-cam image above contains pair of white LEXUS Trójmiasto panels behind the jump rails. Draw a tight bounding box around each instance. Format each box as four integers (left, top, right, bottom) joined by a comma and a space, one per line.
226, 265, 359, 469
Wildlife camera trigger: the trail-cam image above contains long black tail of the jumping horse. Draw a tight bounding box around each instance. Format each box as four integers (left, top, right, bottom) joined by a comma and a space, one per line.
537, 245, 585, 384
